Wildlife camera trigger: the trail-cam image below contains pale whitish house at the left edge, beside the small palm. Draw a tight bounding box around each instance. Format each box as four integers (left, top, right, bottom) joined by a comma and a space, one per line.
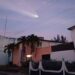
0, 35, 16, 65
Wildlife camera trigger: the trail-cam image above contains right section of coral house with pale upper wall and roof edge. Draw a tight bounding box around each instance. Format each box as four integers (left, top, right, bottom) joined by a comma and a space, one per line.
33, 40, 61, 62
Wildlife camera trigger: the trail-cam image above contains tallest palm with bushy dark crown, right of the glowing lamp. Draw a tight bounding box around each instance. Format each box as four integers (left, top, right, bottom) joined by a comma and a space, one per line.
27, 34, 41, 54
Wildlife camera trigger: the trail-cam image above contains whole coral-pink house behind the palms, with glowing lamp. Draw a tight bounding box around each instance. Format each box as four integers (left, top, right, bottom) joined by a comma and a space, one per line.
13, 39, 61, 66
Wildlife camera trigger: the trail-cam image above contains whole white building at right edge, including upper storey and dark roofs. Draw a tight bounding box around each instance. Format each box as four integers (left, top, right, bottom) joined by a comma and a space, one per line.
51, 25, 75, 62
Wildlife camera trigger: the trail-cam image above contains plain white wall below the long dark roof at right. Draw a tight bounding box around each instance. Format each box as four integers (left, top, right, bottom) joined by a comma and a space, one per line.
51, 50, 75, 62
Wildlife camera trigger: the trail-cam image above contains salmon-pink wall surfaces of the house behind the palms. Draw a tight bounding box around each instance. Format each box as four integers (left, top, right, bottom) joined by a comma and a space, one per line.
13, 43, 51, 66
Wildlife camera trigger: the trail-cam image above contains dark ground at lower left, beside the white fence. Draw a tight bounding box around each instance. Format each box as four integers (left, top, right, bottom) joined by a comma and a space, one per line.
0, 65, 29, 75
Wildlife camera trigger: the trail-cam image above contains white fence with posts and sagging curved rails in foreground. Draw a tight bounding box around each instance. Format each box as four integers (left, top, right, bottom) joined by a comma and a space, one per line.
29, 59, 75, 75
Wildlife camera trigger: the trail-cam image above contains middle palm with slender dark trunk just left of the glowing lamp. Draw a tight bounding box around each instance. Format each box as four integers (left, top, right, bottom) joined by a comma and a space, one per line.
18, 36, 27, 63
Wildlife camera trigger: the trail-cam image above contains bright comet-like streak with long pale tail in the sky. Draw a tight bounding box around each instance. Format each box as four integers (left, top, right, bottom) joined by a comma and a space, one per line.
0, 2, 39, 18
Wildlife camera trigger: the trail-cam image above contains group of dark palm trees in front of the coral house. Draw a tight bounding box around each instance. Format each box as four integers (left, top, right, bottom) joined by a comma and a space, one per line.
4, 34, 41, 63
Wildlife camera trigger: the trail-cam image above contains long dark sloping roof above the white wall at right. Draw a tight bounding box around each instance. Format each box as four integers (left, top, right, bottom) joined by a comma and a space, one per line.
52, 42, 75, 52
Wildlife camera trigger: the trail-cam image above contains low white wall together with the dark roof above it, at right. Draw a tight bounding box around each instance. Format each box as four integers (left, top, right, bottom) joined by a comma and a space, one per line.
51, 42, 75, 63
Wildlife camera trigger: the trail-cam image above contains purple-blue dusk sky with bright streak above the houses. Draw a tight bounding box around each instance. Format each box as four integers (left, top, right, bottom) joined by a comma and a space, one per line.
0, 0, 75, 40
